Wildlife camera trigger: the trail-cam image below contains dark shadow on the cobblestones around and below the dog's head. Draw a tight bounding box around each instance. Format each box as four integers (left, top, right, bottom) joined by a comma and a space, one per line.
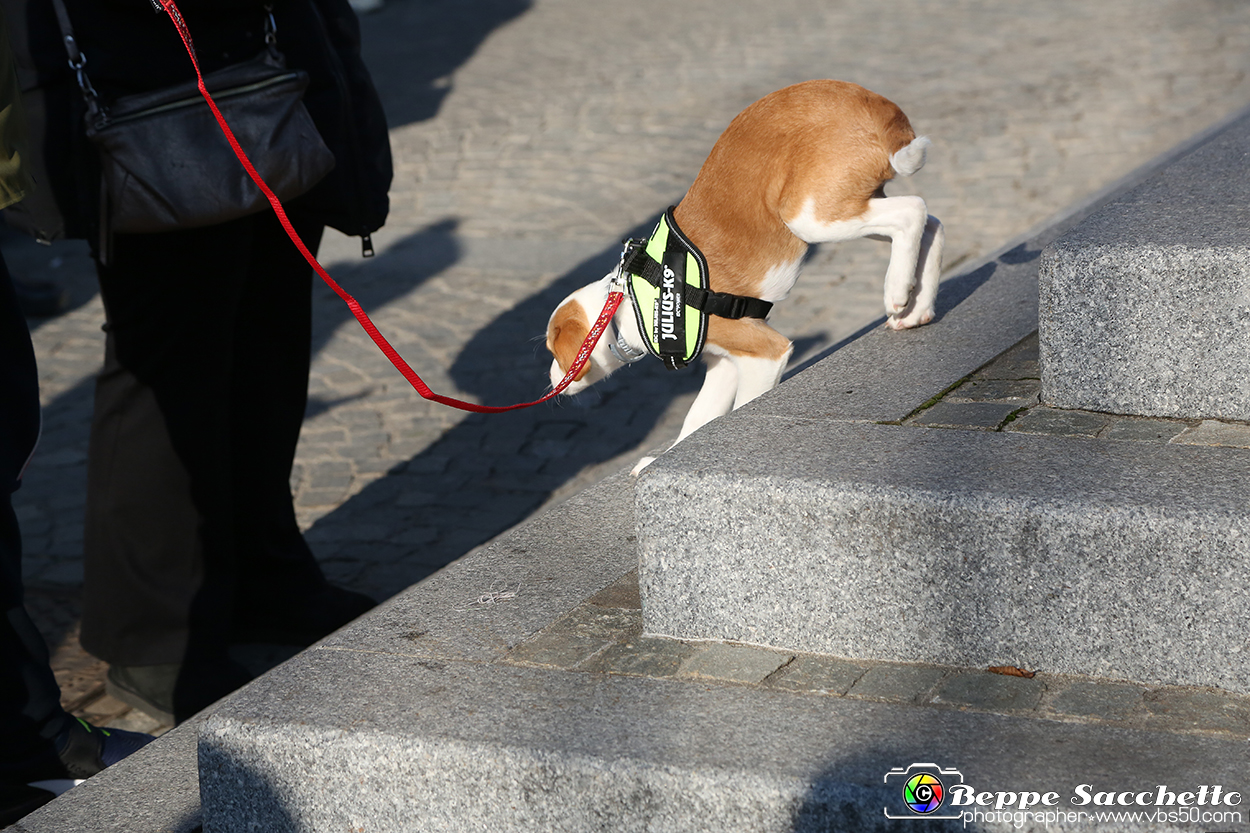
300, 215, 703, 598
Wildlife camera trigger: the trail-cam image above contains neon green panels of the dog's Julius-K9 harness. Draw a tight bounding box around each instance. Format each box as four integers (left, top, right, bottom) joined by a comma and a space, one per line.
628, 208, 708, 370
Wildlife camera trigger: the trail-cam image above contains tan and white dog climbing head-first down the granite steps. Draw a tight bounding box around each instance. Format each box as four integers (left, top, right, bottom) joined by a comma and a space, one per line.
546, 81, 944, 474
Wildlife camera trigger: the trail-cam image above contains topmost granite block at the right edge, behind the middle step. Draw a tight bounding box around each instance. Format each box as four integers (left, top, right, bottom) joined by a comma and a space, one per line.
1039, 116, 1250, 420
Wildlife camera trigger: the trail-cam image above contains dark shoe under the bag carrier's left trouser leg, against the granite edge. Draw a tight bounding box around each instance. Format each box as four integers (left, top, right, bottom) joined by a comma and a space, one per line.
105, 659, 253, 724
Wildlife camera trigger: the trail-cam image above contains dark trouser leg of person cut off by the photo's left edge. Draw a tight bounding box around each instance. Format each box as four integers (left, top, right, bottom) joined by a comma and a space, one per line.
0, 250, 69, 777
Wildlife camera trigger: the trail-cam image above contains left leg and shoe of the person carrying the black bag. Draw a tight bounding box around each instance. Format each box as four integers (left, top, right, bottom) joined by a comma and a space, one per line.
81, 218, 253, 719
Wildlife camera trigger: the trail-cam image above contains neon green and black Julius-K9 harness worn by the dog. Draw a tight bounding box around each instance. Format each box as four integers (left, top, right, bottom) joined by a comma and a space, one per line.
621, 206, 773, 370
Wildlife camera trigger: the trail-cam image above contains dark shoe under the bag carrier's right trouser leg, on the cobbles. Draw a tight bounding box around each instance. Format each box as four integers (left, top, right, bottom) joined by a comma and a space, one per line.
231, 584, 378, 648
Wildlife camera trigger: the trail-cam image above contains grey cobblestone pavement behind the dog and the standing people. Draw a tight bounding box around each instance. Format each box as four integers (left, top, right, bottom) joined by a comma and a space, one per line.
7, 0, 1250, 725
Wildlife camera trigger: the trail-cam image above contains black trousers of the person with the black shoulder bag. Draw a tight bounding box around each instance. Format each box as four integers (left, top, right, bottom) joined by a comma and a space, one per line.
81, 211, 324, 665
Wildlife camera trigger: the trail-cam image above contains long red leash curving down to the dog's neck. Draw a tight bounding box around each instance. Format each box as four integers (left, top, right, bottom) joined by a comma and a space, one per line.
156, 0, 624, 414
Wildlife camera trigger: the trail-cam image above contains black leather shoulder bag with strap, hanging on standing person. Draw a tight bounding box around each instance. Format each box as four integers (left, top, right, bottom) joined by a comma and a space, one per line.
54, 0, 334, 256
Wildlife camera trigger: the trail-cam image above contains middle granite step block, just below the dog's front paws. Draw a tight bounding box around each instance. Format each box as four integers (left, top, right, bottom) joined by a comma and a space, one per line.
638, 413, 1250, 692
